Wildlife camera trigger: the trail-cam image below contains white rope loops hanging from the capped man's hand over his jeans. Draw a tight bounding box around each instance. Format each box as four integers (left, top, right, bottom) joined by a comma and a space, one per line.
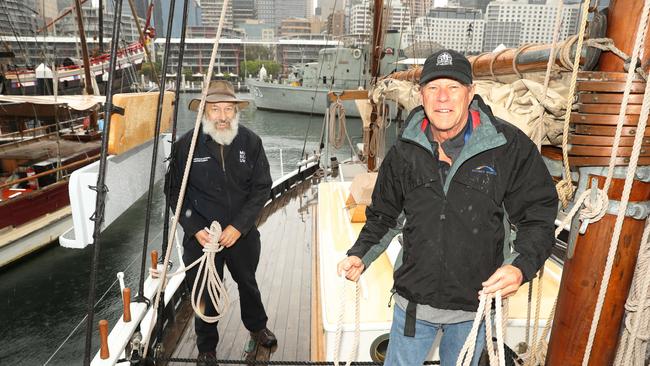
456, 290, 505, 366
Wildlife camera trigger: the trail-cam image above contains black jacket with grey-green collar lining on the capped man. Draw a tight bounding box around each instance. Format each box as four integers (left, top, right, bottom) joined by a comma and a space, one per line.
348, 96, 558, 311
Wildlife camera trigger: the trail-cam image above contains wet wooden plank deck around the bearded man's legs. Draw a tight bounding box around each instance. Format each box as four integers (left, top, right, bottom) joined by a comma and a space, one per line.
169, 182, 316, 366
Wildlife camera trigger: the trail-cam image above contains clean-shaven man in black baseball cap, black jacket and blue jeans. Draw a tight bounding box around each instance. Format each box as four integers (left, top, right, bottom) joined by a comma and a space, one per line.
338, 50, 557, 366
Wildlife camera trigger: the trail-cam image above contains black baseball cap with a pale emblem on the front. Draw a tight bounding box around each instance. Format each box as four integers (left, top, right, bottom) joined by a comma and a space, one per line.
420, 49, 472, 85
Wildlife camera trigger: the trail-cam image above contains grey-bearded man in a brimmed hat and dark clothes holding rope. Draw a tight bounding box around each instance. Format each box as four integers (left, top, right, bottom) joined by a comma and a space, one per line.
168, 80, 277, 361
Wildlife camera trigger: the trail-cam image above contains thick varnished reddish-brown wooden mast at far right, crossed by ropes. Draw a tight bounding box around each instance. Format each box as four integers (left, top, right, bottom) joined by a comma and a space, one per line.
546, 0, 650, 366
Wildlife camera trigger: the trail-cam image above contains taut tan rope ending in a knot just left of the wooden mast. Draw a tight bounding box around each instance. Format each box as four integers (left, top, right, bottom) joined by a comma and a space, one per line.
556, 0, 589, 207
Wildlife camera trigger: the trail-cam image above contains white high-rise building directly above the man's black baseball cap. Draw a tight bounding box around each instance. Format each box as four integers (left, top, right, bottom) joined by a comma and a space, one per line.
406, 8, 485, 53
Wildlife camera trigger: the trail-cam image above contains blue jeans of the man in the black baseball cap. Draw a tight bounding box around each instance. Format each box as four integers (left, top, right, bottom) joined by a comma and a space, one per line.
384, 304, 485, 366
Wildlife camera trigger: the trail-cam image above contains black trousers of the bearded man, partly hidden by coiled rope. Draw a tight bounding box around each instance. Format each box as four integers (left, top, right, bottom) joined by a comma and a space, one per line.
183, 228, 268, 352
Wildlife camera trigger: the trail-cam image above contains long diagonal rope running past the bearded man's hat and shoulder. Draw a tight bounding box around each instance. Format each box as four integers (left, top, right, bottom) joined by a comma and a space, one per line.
143, 0, 228, 357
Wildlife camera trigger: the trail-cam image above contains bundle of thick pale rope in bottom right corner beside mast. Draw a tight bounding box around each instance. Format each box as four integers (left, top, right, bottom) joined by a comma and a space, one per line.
614, 217, 650, 366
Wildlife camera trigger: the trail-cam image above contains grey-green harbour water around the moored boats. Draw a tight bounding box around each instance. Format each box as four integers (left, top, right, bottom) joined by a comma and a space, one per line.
0, 94, 374, 366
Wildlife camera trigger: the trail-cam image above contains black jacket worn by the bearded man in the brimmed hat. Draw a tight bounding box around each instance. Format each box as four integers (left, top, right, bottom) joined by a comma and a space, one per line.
168, 125, 272, 240
